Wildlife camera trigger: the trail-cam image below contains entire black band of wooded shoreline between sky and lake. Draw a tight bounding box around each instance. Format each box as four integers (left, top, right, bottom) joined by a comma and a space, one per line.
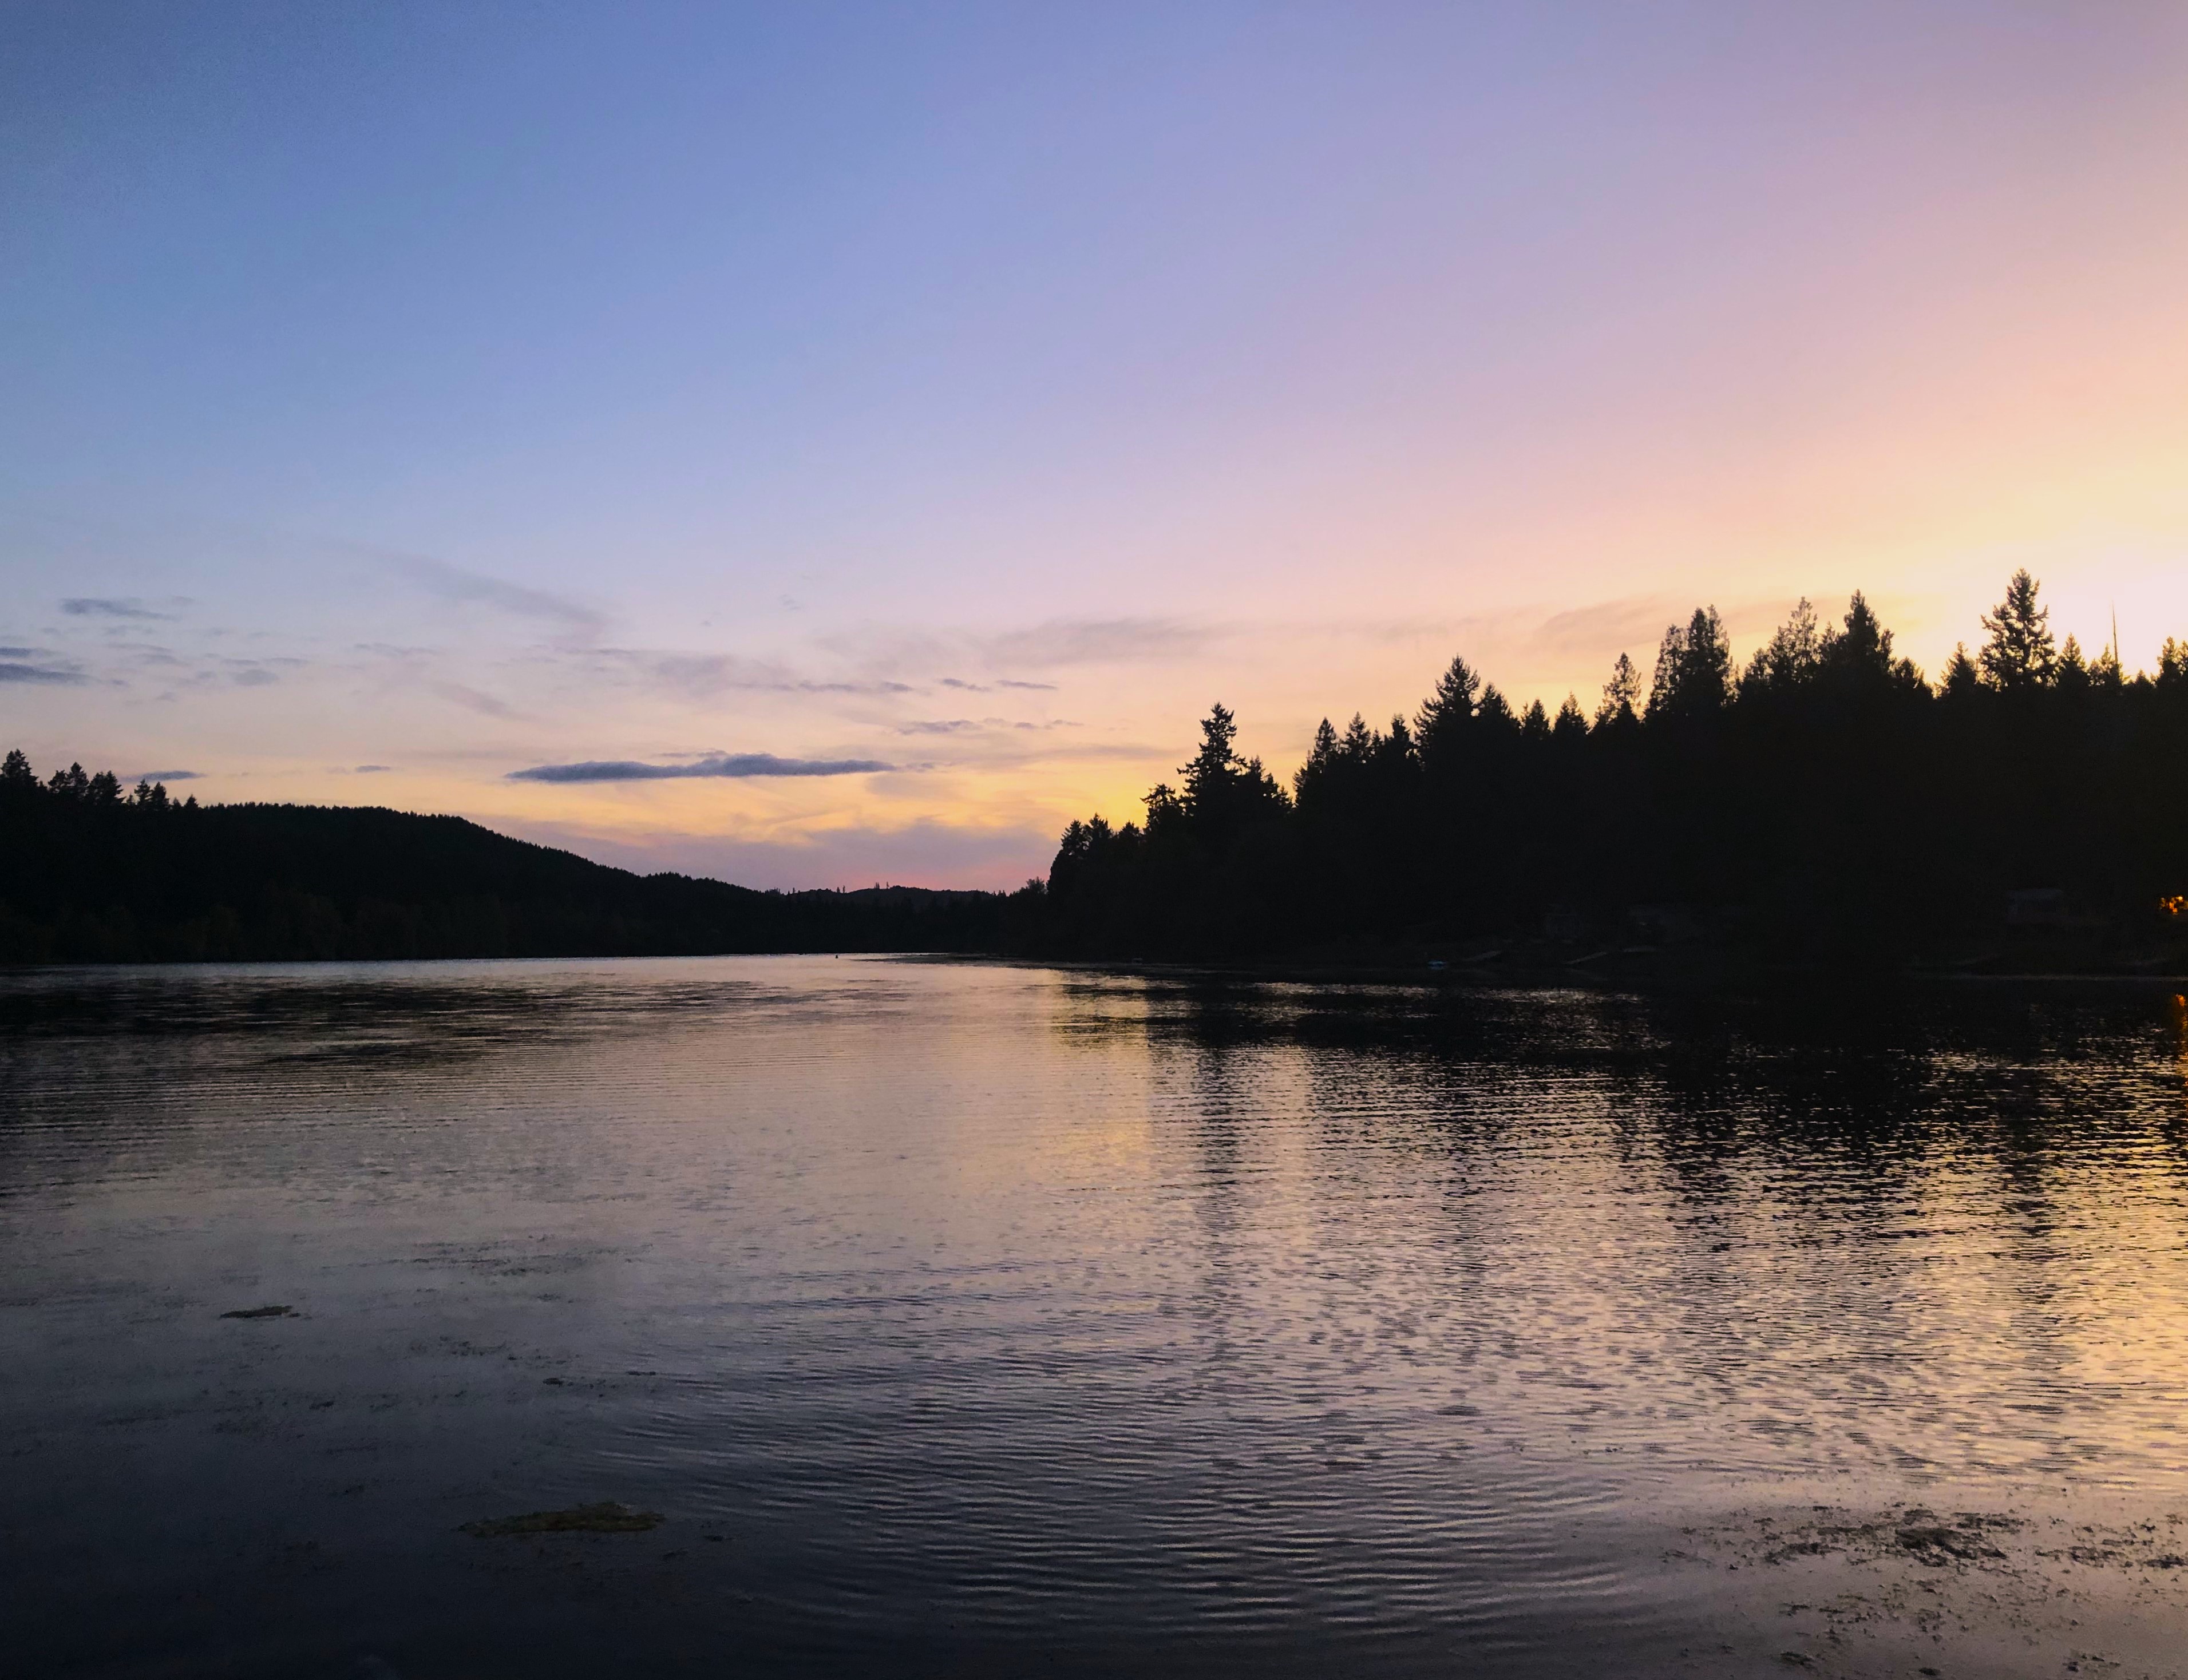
17, 571, 2188, 971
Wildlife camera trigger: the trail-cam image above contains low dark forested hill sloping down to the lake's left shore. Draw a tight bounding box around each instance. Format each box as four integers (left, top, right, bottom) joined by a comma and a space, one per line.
0, 752, 1002, 962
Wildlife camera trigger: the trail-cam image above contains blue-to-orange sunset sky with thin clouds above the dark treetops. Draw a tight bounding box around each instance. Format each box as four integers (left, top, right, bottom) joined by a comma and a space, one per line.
0, 0, 2188, 886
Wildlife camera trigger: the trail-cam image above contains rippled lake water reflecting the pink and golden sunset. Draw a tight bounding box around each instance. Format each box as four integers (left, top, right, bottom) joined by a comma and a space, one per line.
0, 958, 2188, 1678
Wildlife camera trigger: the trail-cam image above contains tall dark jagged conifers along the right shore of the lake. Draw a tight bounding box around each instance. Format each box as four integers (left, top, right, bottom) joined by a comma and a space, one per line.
1011, 571, 2188, 958
